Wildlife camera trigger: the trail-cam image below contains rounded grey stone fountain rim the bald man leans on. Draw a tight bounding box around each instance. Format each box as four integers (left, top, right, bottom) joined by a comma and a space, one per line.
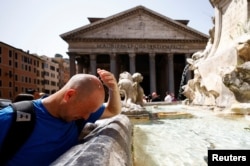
51, 114, 133, 166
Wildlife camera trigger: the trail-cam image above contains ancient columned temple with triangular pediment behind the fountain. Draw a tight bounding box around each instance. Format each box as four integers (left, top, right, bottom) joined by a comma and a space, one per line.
61, 6, 208, 99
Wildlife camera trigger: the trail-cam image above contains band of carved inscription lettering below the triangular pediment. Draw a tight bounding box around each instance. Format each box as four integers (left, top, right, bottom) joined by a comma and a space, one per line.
96, 43, 185, 49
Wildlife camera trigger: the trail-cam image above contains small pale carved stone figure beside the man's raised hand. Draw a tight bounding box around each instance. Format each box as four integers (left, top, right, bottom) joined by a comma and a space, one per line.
118, 71, 144, 105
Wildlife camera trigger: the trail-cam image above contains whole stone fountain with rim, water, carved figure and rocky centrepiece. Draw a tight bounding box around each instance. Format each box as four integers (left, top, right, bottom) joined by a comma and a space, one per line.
54, 0, 250, 166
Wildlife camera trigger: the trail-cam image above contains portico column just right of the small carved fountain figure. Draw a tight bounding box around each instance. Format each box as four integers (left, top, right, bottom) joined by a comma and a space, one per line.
149, 53, 156, 93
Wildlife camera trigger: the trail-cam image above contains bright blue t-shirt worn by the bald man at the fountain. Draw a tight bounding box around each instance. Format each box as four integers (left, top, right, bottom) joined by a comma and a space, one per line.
0, 99, 105, 166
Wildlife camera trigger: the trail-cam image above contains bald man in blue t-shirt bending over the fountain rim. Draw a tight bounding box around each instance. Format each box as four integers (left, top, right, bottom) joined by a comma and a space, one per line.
0, 69, 121, 166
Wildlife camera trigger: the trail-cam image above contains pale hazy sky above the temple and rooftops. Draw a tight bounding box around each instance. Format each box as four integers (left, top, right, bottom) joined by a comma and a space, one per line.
0, 0, 214, 58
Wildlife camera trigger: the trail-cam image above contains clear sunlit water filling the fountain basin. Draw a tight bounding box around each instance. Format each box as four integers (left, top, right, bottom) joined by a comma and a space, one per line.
133, 105, 250, 166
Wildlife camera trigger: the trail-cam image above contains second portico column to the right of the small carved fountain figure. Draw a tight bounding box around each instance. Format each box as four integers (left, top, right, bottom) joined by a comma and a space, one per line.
168, 54, 175, 93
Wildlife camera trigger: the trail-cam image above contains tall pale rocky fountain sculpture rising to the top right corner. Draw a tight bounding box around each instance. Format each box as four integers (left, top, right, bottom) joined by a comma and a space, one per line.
182, 0, 250, 108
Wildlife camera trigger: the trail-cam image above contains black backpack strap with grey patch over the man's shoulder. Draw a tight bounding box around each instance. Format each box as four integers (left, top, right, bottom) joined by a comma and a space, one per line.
0, 101, 36, 165
